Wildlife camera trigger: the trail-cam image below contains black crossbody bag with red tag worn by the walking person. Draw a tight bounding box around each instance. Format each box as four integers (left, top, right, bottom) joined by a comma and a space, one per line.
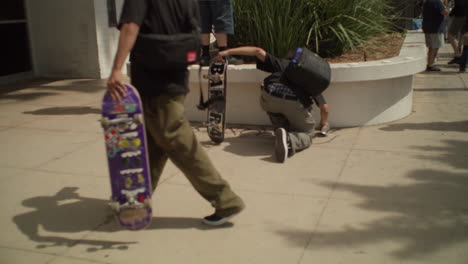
131, 0, 200, 70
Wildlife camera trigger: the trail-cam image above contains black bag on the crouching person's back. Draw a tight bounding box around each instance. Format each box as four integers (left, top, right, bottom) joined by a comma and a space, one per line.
281, 48, 331, 96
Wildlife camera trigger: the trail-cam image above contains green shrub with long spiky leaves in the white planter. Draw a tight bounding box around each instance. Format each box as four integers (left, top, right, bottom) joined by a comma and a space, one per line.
230, 0, 395, 57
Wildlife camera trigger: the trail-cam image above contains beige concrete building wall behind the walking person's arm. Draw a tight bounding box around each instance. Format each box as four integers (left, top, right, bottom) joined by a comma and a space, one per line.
26, 0, 125, 78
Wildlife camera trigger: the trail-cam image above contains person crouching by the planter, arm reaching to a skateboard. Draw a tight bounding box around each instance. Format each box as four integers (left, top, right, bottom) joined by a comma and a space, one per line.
218, 46, 329, 163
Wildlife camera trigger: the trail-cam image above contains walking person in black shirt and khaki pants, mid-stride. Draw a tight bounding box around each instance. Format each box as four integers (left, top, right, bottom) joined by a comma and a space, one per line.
107, 0, 245, 225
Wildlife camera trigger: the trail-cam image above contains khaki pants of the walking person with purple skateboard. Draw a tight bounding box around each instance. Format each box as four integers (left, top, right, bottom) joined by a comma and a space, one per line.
142, 94, 244, 217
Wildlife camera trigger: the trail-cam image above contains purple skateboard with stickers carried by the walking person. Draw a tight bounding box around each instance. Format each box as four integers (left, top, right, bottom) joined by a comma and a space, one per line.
101, 84, 152, 230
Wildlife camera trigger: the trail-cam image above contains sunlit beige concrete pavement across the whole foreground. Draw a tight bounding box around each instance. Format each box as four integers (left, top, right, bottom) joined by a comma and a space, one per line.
0, 45, 468, 264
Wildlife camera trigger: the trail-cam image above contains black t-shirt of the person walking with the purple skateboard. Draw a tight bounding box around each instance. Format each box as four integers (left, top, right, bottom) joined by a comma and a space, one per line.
118, 0, 199, 96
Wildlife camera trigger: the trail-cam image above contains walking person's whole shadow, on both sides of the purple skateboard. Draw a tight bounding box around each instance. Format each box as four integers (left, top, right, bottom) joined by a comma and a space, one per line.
13, 187, 227, 252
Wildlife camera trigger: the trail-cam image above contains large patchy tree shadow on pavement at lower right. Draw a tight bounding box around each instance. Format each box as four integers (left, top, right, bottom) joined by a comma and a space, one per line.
277, 140, 468, 260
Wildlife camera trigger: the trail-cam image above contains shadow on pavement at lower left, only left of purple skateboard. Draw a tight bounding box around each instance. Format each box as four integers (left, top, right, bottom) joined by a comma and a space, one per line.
13, 187, 135, 251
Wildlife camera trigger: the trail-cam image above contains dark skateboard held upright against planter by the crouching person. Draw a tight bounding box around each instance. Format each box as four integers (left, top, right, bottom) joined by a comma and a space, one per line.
204, 61, 228, 144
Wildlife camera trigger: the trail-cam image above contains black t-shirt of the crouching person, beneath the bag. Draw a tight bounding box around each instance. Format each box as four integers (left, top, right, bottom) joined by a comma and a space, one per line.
257, 53, 312, 107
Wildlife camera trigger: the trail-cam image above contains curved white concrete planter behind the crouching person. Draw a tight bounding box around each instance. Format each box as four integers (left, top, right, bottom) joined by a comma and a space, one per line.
186, 31, 426, 127
